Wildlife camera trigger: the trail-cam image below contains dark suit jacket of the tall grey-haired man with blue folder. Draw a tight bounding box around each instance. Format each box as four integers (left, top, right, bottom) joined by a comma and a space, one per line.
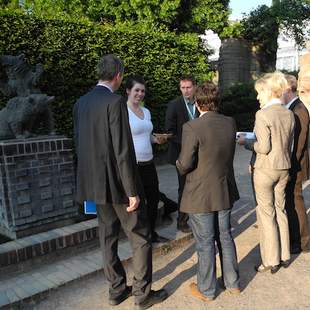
73, 86, 138, 204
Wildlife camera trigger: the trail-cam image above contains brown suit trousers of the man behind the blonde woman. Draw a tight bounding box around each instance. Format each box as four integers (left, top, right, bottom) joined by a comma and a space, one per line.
285, 173, 310, 250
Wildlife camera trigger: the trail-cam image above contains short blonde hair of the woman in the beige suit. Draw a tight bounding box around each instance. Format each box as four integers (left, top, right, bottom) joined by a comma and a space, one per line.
255, 71, 289, 98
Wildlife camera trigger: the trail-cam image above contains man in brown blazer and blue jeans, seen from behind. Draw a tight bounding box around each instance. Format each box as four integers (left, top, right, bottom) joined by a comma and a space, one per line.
176, 82, 240, 301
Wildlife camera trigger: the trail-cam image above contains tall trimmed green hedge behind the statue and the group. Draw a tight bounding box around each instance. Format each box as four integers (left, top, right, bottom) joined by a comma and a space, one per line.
0, 10, 211, 136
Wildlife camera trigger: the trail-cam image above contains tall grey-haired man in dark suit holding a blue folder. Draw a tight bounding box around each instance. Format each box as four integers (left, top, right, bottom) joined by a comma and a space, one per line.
73, 55, 167, 309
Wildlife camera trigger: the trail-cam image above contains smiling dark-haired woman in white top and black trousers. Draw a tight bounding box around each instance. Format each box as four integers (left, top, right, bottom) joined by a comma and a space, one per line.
126, 76, 167, 242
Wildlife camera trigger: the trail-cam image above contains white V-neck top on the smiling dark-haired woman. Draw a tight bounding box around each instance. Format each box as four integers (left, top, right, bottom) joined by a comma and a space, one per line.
127, 106, 153, 162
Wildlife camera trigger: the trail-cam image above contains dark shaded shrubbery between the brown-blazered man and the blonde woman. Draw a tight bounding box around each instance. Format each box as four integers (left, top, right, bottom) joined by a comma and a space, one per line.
220, 83, 259, 131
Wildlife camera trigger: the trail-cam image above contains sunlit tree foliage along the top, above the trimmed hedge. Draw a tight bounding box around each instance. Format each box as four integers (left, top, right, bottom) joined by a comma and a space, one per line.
0, 0, 229, 33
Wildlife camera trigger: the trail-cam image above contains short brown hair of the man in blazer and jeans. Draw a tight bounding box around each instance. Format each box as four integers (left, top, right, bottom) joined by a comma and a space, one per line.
195, 82, 220, 111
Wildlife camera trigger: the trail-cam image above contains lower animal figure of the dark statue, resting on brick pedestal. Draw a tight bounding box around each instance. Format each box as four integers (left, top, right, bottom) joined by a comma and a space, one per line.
0, 94, 54, 140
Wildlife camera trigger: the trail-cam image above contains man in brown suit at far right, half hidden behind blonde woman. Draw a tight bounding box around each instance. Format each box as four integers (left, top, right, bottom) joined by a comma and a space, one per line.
284, 75, 310, 254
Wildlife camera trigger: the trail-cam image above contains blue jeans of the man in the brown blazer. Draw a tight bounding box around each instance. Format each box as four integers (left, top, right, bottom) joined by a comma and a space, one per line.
189, 210, 239, 298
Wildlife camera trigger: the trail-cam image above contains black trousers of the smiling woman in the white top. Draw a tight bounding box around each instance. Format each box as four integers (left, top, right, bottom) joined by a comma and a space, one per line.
138, 162, 159, 236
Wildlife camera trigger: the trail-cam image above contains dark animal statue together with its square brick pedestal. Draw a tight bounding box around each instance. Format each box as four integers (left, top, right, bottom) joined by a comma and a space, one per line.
0, 55, 78, 239
